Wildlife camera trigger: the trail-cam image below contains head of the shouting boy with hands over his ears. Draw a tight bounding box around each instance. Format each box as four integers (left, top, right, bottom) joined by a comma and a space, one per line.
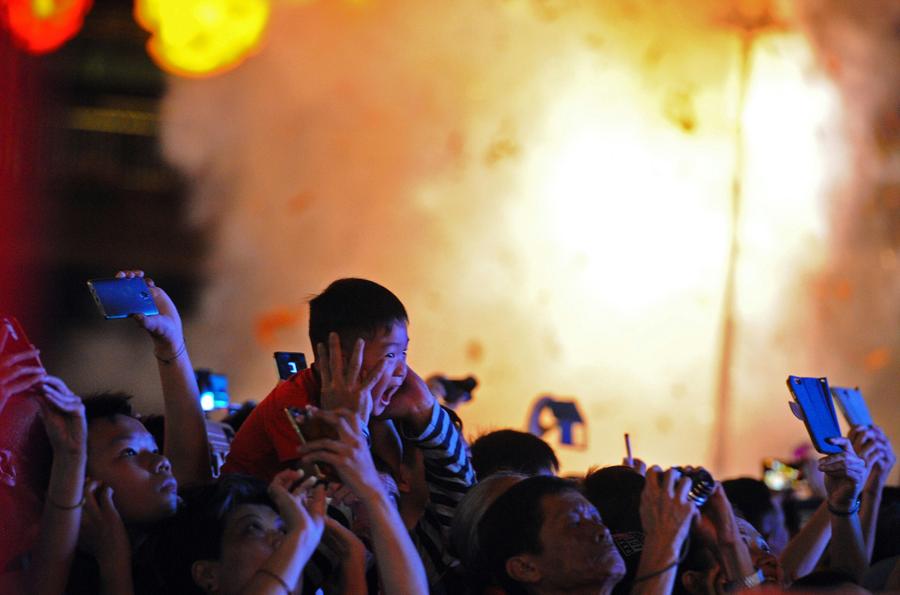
309, 279, 409, 416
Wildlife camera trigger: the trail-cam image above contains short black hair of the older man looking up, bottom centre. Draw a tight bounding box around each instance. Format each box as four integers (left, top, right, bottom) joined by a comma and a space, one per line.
473, 475, 578, 595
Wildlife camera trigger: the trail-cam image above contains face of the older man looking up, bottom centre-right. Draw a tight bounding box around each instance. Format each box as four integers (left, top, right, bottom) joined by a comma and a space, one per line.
535, 490, 625, 590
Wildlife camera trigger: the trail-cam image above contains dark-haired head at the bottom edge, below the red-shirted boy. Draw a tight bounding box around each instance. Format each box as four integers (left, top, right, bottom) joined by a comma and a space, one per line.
158, 475, 284, 594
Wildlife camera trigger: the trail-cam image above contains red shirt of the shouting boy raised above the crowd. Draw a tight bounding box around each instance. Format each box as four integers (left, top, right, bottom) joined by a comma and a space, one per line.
222, 368, 322, 482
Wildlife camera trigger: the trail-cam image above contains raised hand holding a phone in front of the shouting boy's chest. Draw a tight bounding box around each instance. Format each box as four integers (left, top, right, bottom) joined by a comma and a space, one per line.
297, 409, 382, 499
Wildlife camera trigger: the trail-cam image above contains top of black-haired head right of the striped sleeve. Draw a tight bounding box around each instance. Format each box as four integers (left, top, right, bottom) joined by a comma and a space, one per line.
471, 430, 559, 479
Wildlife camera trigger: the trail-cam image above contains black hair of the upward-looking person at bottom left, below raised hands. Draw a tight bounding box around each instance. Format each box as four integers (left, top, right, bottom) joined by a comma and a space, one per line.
154, 474, 278, 594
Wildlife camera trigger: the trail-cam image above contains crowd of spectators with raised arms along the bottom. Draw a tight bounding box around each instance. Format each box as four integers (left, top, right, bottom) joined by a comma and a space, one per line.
0, 271, 900, 595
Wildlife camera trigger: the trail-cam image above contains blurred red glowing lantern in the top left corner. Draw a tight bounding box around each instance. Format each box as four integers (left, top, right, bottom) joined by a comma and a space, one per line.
0, 0, 91, 54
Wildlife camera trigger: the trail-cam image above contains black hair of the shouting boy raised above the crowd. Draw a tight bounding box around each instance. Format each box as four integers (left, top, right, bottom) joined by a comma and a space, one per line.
309, 278, 409, 350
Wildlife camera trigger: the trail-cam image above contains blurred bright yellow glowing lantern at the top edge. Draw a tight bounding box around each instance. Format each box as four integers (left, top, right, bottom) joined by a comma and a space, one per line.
134, 0, 270, 76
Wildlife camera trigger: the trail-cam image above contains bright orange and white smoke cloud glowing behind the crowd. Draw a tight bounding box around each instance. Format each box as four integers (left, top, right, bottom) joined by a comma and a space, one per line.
51, 0, 900, 475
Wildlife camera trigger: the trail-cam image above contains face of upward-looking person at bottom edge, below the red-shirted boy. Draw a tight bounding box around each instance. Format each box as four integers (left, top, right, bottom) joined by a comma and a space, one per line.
201, 504, 285, 595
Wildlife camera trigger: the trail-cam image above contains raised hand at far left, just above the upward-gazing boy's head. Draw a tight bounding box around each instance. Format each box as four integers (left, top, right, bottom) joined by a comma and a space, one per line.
38, 376, 87, 457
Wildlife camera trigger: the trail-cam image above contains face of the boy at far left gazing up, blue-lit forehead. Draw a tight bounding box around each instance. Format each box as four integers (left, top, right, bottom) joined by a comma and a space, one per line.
87, 415, 178, 523
